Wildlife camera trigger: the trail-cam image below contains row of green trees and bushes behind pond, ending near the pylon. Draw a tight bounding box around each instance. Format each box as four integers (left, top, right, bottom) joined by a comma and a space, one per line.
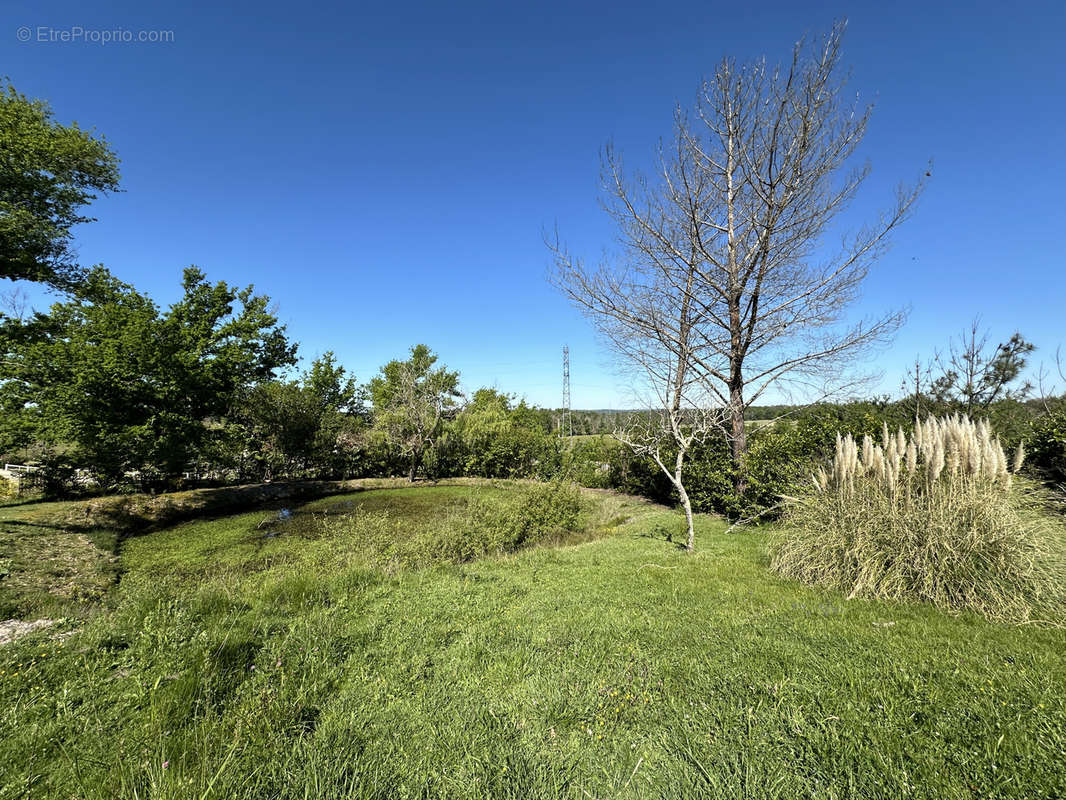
0, 268, 575, 490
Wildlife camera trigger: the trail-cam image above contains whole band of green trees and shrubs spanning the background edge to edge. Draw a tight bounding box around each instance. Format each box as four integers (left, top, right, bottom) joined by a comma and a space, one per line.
0, 76, 1066, 514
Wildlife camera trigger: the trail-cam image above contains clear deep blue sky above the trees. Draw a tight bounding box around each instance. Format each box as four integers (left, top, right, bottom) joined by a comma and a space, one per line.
0, 0, 1066, 407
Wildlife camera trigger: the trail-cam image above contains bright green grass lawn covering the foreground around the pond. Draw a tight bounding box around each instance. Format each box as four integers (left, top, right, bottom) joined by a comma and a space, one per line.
0, 483, 1066, 800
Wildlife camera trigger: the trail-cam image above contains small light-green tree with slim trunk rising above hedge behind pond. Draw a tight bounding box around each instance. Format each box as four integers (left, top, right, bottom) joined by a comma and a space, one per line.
370, 345, 459, 481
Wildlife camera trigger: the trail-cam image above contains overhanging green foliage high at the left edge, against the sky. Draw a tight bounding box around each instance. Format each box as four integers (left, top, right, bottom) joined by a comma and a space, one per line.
0, 83, 118, 289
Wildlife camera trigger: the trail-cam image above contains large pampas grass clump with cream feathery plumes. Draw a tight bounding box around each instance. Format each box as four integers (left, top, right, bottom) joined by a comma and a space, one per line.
771, 416, 1066, 622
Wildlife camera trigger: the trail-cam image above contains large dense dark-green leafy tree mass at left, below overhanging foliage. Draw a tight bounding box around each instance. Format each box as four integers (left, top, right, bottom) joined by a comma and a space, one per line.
0, 268, 295, 485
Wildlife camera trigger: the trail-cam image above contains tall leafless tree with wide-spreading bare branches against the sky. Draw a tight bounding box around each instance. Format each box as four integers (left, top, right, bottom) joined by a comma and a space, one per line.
555, 23, 930, 501
